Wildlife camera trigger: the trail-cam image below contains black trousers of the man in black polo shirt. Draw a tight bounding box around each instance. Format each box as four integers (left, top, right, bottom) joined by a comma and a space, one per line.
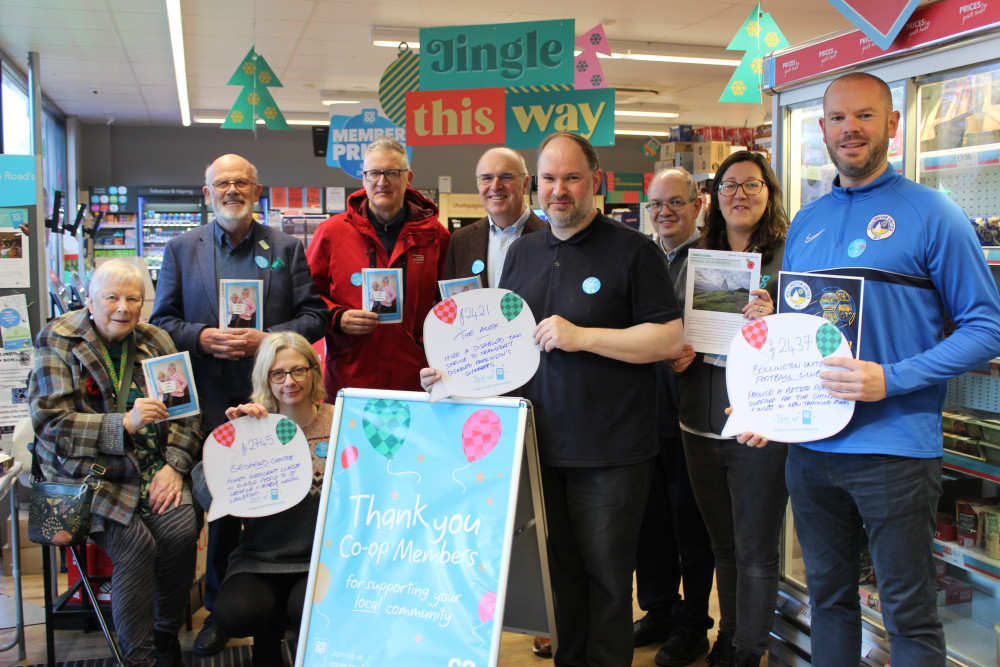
542, 461, 652, 667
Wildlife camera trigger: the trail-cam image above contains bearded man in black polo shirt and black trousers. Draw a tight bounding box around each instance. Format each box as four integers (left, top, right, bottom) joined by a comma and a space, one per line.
500, 132, 683, 667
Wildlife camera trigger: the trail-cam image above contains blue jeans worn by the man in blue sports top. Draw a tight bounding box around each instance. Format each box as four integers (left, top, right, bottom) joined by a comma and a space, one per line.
787, 446, 946, 667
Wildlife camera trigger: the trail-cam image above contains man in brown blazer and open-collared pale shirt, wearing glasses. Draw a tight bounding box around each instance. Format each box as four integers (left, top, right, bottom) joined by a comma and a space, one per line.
442, 148, 545, 287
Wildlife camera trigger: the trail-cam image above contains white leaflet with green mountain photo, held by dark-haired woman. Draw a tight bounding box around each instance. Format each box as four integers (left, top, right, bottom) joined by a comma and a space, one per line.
684, 250, 760, 354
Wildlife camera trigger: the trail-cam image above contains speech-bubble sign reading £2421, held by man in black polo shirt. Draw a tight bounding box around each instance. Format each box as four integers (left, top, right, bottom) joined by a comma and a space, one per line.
424, 288, 539, 402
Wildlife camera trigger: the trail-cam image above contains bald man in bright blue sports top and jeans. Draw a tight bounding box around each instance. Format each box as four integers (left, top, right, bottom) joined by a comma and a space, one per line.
783, 73, 1000, 667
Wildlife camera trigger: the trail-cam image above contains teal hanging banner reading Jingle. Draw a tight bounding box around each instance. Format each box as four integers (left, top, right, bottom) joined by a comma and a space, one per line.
420, 19, 575, 90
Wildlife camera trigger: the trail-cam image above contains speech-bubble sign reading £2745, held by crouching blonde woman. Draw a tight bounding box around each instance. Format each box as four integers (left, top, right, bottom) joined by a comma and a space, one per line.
202, 415, 313, 521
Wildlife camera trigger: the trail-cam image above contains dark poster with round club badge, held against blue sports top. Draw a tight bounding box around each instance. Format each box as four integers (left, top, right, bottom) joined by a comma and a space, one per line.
778, 271, 865, 359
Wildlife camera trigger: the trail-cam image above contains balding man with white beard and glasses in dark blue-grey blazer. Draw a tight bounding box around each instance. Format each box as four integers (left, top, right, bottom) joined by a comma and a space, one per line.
150, 155, 330, 655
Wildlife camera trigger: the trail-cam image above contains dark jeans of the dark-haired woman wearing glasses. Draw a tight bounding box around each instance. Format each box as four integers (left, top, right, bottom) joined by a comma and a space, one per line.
682, 432, 788, 655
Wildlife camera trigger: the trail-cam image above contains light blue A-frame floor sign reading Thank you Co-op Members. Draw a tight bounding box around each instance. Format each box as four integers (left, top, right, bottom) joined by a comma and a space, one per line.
295, 389, 555, 667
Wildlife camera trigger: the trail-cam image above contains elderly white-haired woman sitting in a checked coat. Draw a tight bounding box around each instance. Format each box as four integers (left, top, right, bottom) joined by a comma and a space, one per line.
29, 260, 200, 667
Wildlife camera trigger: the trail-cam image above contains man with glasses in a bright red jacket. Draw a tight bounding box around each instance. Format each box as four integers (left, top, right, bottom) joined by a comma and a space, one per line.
306, 138, 449, 400
